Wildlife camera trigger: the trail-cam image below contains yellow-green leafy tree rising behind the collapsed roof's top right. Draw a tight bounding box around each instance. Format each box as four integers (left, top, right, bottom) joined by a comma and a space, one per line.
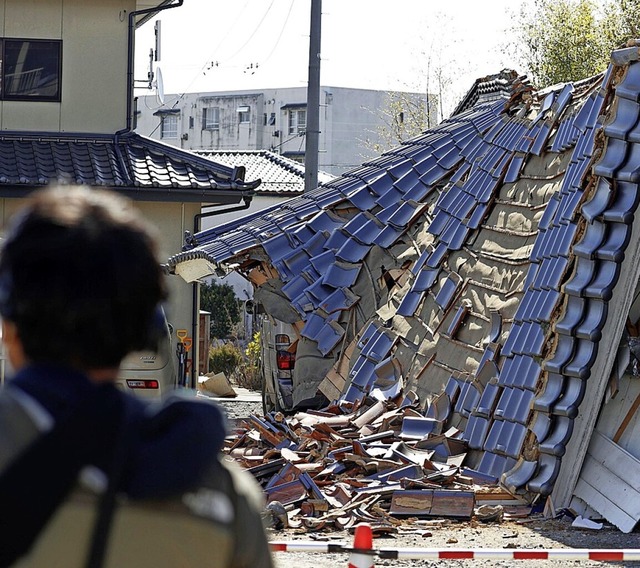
518, 0, 640, 87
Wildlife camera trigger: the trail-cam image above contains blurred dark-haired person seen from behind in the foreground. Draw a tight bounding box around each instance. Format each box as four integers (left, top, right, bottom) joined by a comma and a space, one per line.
0, 186, 272, 568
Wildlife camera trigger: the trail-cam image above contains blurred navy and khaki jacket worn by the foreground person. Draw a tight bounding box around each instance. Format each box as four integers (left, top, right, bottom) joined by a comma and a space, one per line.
0, 365, 271, 568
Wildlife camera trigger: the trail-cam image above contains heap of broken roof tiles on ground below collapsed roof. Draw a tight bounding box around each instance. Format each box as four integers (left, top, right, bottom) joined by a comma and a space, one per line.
225, 397, 531, 533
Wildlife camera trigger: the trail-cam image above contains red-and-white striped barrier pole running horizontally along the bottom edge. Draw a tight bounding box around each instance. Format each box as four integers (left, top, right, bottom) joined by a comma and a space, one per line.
270, 540, 640, 562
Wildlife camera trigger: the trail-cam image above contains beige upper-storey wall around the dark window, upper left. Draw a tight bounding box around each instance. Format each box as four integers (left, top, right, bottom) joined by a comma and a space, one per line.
0, 0, 131, 133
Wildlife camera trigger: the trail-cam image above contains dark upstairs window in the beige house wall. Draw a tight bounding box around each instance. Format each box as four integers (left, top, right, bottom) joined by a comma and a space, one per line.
0, 39, 62, 102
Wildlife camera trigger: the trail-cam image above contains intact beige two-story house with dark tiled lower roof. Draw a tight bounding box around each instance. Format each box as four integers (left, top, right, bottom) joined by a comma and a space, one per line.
0, 0, 259, 390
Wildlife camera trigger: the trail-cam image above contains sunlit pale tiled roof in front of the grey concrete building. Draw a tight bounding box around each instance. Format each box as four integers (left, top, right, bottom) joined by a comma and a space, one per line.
195, 150, 334, 197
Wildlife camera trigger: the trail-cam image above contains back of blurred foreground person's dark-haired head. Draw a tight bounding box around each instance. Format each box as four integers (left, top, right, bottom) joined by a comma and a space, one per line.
0, 186, 166, 369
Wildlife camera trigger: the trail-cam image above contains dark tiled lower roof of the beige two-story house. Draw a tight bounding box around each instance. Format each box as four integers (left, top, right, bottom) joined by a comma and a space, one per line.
0, 131, 260, 202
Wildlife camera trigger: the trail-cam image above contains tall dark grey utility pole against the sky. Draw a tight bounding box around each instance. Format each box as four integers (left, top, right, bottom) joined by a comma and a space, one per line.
304, 0, 322, 192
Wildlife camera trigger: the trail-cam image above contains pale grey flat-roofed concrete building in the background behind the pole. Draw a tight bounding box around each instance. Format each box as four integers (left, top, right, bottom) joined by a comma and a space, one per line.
136, 86, 435, 175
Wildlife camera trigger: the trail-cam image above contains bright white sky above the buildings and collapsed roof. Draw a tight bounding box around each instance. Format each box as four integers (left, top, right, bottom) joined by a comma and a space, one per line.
135, 0, 531, 116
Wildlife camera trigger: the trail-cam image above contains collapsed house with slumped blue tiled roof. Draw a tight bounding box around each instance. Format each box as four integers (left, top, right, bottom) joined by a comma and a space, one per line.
168, 45, 640, 531
